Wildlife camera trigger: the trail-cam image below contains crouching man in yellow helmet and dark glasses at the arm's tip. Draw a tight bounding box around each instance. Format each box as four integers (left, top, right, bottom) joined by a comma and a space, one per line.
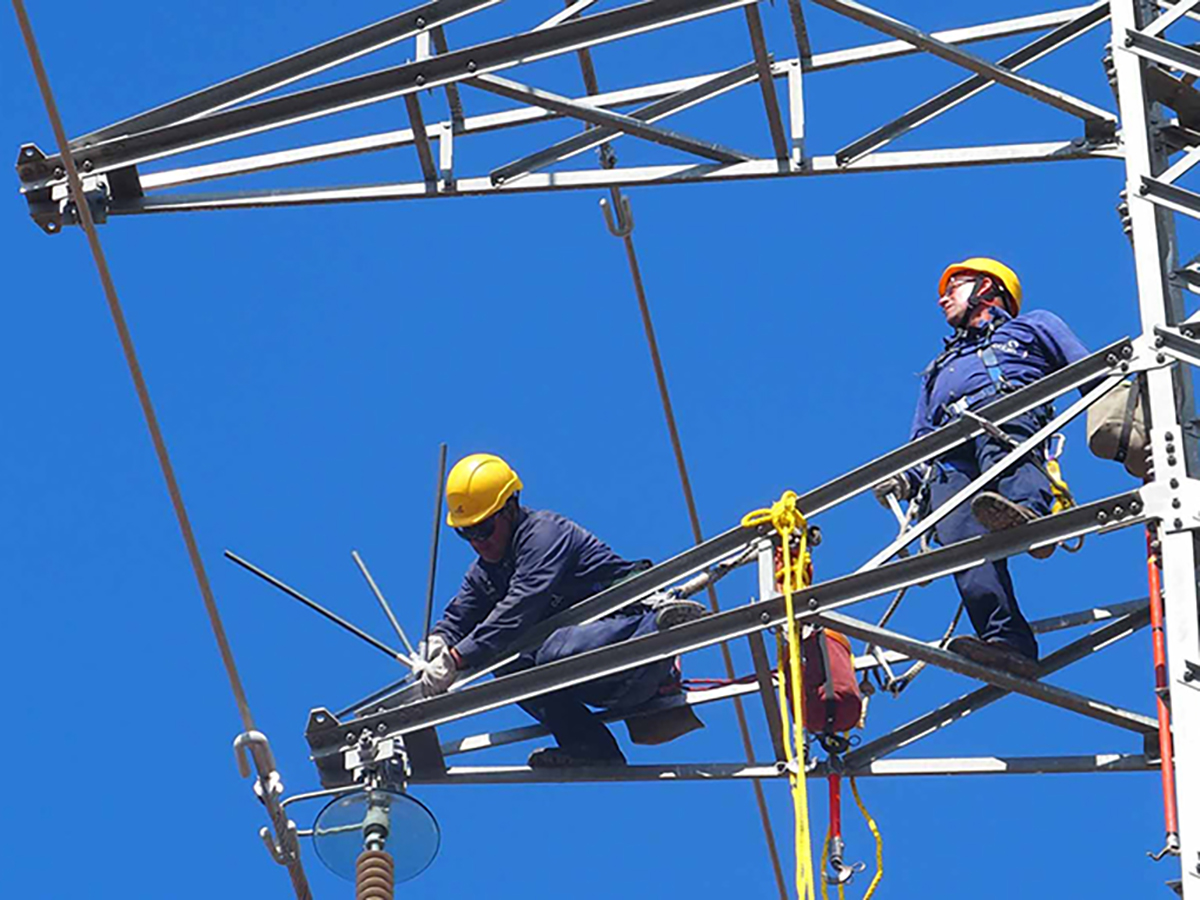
421, 454, 707, 768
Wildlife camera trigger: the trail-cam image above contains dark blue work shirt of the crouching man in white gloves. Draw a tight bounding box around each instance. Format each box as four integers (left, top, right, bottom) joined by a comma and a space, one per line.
433, 506, 648, 668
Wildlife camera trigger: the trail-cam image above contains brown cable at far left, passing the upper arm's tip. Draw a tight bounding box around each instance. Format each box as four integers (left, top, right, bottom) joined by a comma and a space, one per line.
12, 10, 312, 900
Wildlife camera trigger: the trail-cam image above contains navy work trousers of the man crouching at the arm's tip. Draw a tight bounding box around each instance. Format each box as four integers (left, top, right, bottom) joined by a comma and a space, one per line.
497, 607, 674, 761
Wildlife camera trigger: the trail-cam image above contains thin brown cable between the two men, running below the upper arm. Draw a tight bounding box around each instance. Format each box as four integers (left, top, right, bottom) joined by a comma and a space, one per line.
612, 188, 787, 900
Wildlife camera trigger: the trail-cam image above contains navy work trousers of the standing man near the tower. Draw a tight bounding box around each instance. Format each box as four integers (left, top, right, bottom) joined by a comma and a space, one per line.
930, 413, 1054, 659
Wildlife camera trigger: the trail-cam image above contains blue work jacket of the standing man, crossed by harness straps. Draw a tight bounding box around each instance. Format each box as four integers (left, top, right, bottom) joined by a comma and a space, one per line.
908, 307, 1087, 440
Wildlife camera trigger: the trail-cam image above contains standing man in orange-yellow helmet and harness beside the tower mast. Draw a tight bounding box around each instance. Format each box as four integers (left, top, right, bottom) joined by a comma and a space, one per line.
875, 257, 1087, 678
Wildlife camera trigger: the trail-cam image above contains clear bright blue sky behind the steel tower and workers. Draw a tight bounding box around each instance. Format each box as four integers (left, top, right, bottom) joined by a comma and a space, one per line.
0, 0, 1190, 900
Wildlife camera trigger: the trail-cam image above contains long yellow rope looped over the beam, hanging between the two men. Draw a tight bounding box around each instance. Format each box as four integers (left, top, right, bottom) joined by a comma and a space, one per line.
742, 491, 815, 900
